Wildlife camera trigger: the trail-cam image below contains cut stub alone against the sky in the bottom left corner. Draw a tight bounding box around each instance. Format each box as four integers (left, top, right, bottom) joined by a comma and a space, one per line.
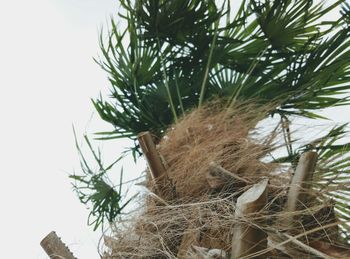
40, 231, 77, 259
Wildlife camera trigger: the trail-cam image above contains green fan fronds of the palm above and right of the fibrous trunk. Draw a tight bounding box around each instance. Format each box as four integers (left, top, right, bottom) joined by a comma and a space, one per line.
72, 0, 350, 258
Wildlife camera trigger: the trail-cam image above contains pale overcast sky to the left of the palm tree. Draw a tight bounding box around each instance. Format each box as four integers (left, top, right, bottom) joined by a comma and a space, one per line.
0, 0, 349, 259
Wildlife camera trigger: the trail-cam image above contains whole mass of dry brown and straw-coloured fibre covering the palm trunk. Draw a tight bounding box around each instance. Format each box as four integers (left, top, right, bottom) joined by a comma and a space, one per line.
104, 102, 350, 259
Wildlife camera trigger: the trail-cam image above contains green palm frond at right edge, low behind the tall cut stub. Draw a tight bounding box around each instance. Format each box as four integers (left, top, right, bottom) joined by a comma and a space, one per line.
275, 123, 350, 242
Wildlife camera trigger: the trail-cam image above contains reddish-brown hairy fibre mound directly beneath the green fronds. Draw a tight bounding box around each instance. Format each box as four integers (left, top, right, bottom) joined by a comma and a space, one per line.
159, 103, 274, 199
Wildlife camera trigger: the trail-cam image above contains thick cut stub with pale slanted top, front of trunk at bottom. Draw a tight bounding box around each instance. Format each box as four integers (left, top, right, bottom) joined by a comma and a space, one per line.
231, 179, 268, 259
